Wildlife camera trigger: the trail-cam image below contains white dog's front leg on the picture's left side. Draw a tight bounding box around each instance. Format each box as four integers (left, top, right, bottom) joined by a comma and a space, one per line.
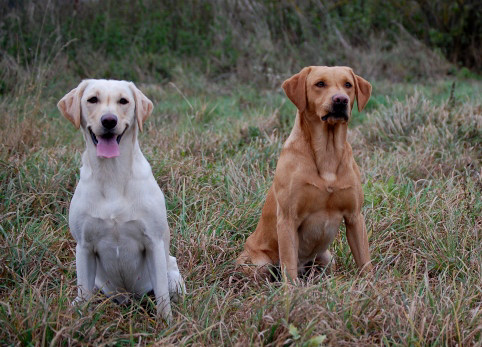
73, 244, 96, 304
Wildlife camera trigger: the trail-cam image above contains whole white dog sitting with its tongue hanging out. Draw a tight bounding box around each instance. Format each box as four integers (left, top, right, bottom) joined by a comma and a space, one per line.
57, 80, 185, 321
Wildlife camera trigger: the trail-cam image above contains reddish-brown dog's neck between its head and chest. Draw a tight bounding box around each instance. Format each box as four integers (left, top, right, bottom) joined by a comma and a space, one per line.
298, 114, 348, 176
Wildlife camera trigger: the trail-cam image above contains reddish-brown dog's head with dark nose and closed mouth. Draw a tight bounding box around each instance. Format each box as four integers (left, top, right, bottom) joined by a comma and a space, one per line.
283, 66, 372, 124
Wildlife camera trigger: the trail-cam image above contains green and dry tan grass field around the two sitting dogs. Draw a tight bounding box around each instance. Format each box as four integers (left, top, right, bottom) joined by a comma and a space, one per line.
0, 68, 482, 346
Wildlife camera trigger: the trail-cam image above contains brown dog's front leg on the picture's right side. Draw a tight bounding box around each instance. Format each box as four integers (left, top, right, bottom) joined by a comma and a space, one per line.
345, 213, 372, 271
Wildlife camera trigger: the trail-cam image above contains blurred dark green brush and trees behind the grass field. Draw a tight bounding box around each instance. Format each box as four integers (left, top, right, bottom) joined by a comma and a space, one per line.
0, 0, 482, 89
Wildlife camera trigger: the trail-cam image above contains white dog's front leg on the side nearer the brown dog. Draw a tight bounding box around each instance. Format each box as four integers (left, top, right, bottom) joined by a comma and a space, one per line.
146, 240, 172, 323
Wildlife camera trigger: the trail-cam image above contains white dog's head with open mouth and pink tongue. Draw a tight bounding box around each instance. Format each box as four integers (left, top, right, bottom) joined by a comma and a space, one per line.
57, 79, 153, 158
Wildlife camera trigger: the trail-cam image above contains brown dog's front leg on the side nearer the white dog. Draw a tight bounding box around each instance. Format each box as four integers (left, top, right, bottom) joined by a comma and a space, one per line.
277, 213, 299, 280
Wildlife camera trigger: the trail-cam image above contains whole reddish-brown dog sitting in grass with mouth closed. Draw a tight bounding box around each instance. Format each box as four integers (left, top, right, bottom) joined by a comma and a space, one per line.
237, 66, 372, 279
